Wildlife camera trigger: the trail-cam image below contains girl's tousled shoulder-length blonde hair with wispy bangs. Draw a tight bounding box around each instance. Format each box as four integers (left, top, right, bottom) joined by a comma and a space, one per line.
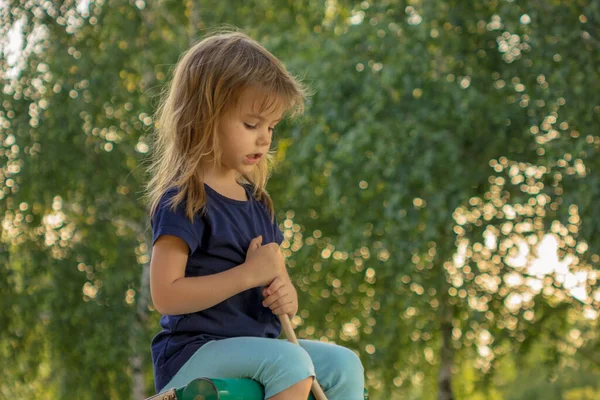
145, 31, 308, 222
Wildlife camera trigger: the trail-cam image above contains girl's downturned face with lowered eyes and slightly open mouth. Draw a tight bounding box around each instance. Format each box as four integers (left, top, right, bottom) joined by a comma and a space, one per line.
218, 88, 283, 178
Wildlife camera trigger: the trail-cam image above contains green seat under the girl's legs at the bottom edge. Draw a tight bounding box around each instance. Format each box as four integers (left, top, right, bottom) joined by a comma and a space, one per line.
146, 378, 368, 400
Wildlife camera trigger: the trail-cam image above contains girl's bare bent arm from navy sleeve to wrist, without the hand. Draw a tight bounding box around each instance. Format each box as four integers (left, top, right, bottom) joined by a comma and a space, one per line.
150, 235, 258, 315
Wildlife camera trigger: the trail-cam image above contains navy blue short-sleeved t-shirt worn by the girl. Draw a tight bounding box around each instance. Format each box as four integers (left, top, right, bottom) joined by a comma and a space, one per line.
152, 184, 283, 392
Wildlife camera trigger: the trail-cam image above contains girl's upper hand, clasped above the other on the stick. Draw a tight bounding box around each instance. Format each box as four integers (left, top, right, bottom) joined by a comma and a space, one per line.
245, 236, 286, 287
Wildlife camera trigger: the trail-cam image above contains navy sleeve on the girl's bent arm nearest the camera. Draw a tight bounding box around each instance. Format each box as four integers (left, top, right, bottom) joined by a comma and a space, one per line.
152, 192, 204, 255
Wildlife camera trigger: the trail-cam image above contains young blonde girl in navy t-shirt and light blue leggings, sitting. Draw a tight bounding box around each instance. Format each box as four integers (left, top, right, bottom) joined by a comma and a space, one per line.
147, 32, 364, 400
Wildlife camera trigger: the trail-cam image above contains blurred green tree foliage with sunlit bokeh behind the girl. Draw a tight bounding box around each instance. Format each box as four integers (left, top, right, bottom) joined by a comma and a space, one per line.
0, 0, 600, 400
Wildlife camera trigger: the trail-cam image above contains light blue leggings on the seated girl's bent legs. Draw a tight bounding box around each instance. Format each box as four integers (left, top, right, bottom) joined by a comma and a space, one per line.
161, 337, 364, 400
